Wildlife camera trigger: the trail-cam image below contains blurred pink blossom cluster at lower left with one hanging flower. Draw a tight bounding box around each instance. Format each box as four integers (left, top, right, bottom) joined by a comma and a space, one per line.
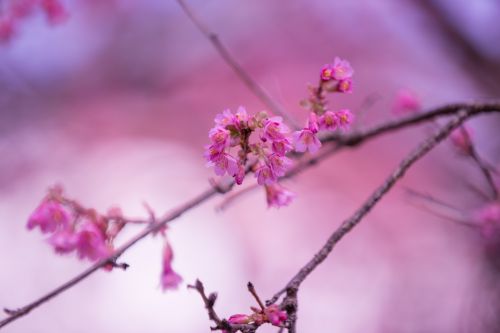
27, 187, 182, 290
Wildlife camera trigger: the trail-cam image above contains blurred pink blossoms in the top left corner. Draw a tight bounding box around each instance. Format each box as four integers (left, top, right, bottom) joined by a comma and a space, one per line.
0, 0, 68, 43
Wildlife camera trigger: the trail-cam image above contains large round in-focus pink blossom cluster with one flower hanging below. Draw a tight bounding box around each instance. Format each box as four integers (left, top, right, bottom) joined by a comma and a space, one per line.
205, 107, 293, 207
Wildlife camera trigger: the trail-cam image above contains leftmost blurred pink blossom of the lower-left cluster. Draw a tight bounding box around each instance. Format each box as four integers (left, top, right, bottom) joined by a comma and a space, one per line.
27, 200, 71, 233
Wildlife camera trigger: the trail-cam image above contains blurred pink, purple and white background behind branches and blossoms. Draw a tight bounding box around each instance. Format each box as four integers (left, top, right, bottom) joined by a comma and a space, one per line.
0, 0, 500, 333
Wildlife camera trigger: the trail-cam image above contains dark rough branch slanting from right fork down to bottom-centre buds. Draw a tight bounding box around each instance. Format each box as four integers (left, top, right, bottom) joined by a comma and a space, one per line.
268, 108, 488, 316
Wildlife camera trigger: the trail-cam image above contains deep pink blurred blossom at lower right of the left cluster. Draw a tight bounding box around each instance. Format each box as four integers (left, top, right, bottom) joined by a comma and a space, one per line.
75, 219, 113, 261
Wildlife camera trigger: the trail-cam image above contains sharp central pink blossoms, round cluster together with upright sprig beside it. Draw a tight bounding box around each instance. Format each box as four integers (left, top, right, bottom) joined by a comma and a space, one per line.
204, 58, 353, 207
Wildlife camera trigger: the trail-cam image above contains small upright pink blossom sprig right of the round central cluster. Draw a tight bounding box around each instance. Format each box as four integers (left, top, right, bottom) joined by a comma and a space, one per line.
293, 58, 354, 153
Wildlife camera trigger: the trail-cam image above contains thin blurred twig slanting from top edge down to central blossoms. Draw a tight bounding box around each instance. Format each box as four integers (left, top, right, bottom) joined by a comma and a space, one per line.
177, 0, 299, 128
